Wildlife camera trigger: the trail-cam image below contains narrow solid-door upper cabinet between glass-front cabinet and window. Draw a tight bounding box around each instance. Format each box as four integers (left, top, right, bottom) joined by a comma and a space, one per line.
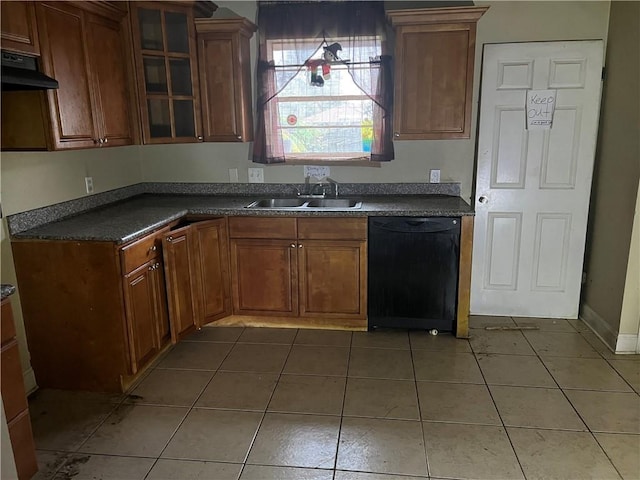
196, 18, 258, 142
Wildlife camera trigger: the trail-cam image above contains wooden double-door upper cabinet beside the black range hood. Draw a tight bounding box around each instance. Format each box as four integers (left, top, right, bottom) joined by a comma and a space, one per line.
2, 2, 135, 150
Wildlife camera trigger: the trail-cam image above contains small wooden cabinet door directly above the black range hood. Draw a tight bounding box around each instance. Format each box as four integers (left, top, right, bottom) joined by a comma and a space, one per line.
0, 1, 40, 55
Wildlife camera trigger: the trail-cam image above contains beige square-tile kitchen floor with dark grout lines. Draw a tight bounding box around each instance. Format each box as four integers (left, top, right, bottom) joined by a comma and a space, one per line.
30, 317, 640, 480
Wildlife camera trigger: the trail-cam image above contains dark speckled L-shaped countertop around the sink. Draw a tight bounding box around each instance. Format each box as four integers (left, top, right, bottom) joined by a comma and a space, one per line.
8, 194, 474, 244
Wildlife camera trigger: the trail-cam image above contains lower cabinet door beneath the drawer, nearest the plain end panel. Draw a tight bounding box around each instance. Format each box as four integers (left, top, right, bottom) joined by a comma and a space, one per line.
125, 261, 160, 374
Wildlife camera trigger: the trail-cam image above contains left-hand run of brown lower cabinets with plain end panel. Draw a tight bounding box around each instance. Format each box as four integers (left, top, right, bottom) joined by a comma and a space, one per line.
12, 218, 230, 392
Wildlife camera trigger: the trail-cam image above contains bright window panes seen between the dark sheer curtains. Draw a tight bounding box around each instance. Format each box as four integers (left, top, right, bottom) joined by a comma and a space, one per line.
269, 39, 380, 160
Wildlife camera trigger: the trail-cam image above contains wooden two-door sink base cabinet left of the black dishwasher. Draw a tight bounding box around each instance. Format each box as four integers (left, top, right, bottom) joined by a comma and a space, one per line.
229, 217, 367, 326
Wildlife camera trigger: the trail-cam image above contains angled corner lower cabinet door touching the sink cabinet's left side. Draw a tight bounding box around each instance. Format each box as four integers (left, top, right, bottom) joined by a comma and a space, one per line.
193, 218, 231, 324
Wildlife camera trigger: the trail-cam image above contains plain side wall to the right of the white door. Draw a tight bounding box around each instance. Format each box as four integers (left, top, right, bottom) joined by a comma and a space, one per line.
581, 2, 640, 351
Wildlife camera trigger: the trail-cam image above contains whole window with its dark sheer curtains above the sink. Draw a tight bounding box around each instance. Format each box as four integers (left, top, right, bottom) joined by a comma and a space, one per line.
253, 2, 393, 163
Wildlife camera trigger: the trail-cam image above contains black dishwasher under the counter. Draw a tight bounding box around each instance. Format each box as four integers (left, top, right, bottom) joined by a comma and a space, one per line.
368, 217, 460, 331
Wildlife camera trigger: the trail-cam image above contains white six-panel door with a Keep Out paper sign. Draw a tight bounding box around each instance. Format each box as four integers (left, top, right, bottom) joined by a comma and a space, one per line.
471, 41, 603, 318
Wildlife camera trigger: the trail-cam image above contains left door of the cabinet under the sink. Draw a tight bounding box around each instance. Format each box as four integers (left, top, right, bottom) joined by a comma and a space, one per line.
231, 238, 298, 316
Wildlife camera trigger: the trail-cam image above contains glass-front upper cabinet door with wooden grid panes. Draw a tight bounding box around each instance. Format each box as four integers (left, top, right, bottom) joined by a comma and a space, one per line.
131, 2, 202, 143
